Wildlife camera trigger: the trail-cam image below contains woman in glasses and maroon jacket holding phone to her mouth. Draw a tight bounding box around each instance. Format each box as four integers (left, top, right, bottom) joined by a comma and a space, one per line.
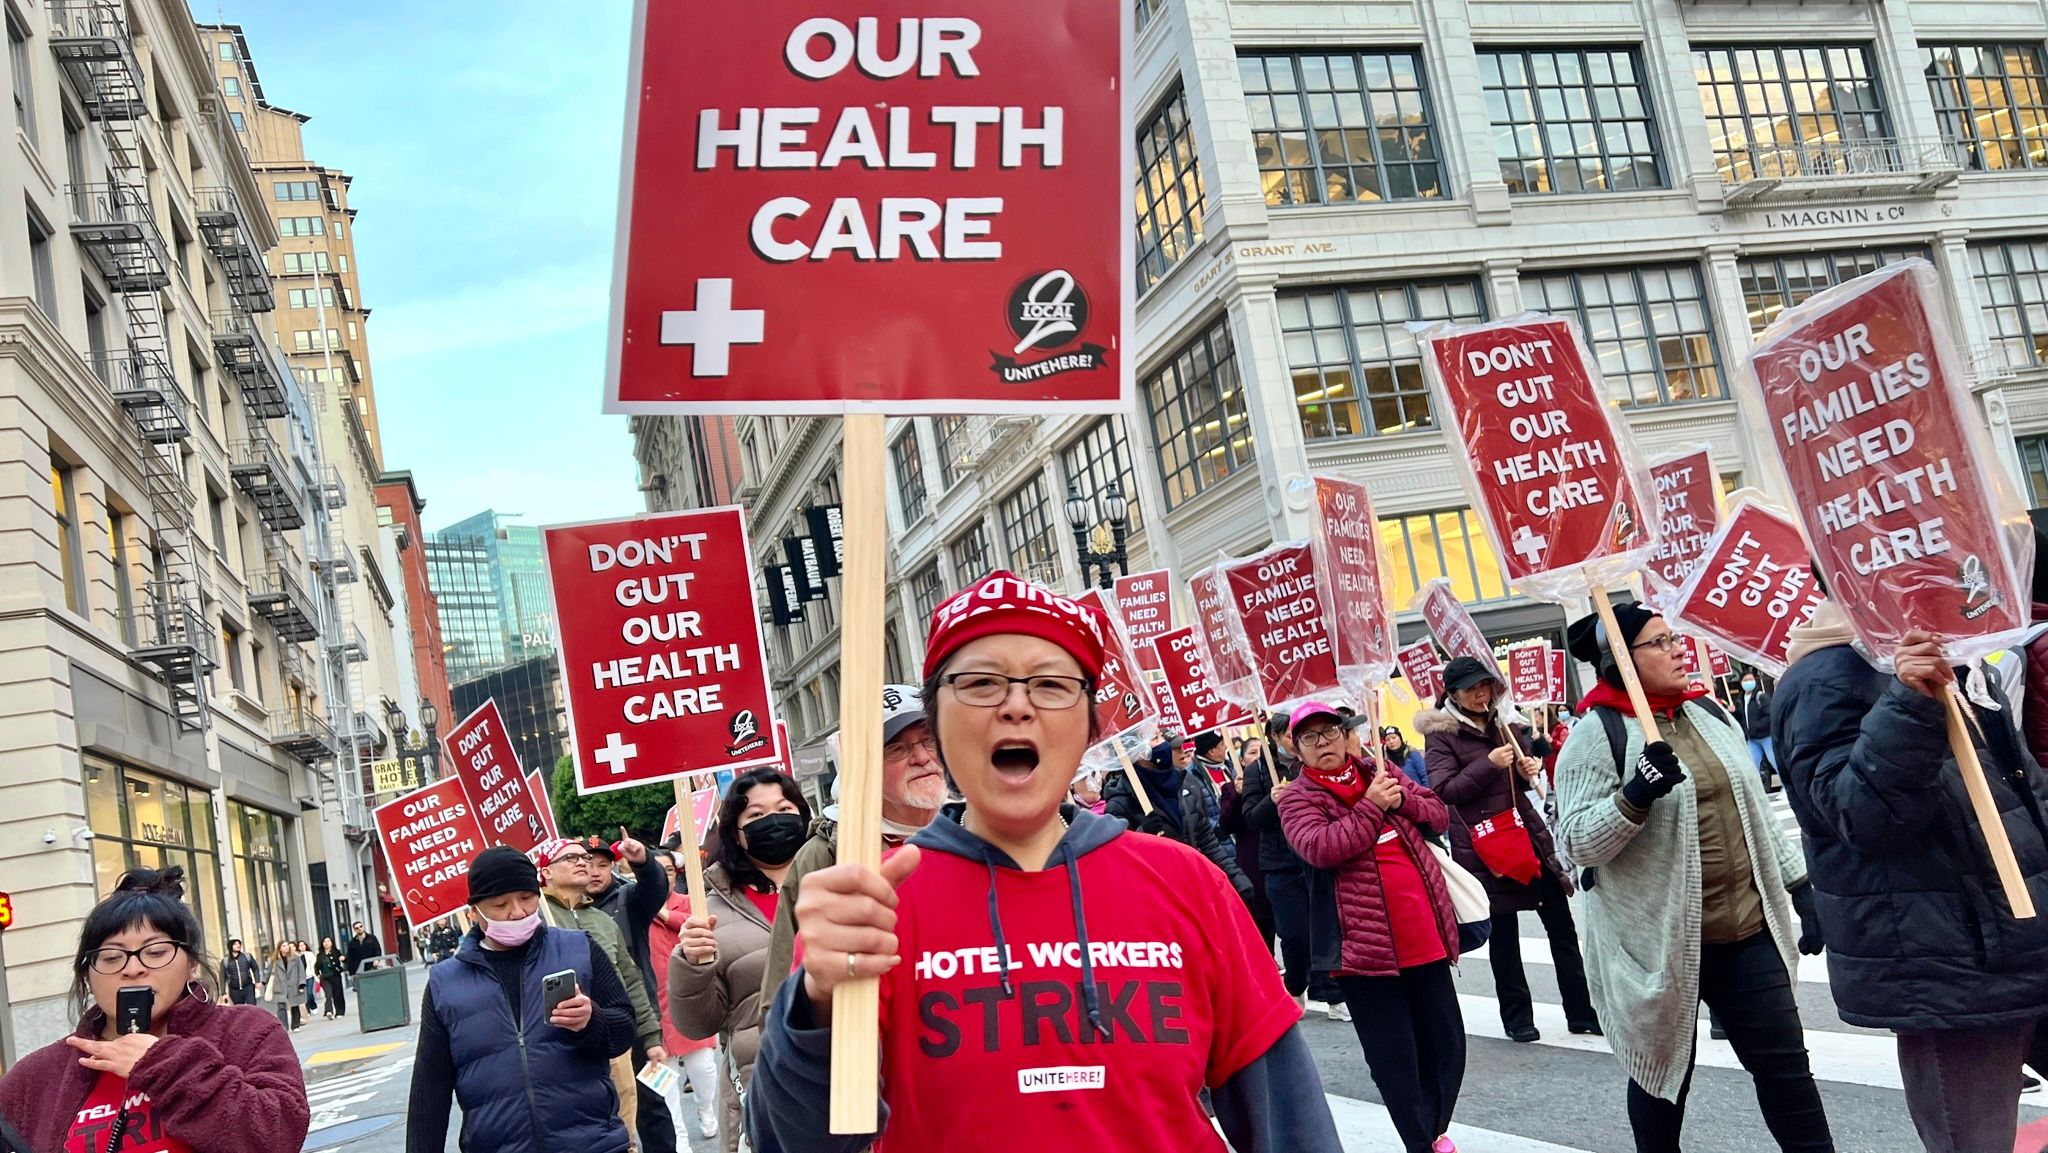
0, 866, 311, 1153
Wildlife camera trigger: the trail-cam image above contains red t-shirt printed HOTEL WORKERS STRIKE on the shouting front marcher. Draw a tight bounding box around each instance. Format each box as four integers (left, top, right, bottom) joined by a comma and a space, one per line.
877, 836, 1300, 1153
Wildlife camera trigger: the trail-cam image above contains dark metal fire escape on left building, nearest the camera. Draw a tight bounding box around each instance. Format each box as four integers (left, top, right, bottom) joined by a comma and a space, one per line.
49, 0, 215, 733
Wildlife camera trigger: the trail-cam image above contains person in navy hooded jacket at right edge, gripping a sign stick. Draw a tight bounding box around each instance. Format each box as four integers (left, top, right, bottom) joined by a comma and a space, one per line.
1777, 600, 2048, 1153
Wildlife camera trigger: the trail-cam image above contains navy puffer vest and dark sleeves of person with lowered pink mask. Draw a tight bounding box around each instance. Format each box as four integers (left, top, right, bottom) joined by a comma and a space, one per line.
408, 926, 635, 1153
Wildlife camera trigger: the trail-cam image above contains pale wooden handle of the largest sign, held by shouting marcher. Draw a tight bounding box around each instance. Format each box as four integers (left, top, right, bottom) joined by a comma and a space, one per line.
829, 412, 889, 1133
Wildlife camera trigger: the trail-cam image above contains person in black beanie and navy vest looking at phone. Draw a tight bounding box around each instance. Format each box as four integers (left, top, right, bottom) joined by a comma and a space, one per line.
407, 846, 635, 1153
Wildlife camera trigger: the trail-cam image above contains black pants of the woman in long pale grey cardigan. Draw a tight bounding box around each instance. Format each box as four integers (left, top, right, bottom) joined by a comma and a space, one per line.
1628, 932, 1835, 1153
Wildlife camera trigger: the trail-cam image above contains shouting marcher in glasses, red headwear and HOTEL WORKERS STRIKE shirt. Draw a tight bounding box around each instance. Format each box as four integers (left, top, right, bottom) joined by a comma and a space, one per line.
745, 571, 1337, 1153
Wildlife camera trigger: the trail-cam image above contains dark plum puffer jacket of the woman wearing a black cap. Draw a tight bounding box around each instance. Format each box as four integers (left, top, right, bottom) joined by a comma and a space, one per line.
1415, 709, 1565, 913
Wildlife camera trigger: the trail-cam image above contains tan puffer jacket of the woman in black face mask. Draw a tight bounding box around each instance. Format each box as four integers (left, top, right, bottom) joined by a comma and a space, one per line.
668, 864, 774, 1153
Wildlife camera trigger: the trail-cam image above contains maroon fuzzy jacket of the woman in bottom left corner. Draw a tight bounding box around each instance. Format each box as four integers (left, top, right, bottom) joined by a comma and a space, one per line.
0, 997, 311, 1153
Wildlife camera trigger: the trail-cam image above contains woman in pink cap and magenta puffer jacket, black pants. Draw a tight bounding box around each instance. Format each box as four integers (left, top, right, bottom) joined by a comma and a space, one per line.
1278, 700, 1464, 1153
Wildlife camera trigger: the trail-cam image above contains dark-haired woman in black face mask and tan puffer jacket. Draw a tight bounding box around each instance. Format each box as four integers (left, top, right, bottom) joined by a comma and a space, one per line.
668, 768, 811, 1153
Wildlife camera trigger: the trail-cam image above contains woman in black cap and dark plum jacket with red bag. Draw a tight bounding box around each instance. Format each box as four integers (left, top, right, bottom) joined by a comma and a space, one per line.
1415, 657, 1599, 1042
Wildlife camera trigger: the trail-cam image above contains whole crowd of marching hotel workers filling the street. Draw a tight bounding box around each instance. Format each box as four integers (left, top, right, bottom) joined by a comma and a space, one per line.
12, 573, 2048, 1153
